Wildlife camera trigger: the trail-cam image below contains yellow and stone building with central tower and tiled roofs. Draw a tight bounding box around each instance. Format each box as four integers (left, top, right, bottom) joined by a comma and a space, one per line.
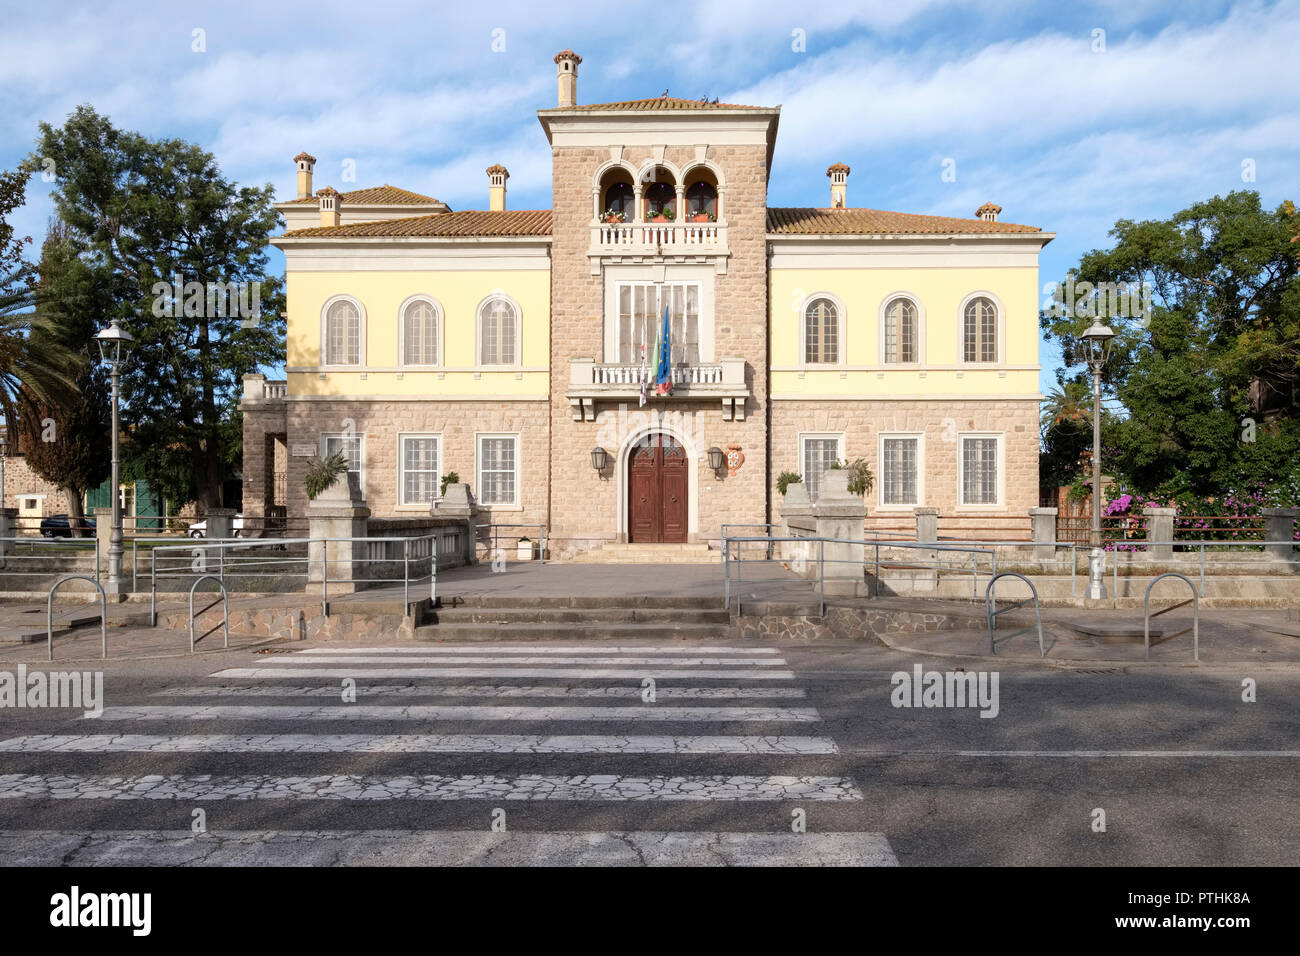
242, 49, 1053, 557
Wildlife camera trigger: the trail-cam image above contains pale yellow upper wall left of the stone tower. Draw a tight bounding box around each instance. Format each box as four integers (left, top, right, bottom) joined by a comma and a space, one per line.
286, 269, 551, 397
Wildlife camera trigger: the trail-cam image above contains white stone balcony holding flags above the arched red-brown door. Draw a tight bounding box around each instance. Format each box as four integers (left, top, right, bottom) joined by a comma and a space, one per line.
566, 358, 750, 421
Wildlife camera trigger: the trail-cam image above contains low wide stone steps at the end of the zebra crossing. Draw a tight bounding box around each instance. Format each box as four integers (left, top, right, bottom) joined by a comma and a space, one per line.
413, 594, 732, 641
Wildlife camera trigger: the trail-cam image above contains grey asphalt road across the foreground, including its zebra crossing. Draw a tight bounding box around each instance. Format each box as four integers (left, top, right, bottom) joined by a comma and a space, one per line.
0, 641, 1300, 866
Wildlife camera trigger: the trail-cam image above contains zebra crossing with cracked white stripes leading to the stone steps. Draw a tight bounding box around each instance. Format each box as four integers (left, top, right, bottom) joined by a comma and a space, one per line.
0, 644, 897, 865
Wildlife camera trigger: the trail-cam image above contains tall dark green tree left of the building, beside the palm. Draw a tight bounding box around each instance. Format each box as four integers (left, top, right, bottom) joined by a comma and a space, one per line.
29, 105, 285, 507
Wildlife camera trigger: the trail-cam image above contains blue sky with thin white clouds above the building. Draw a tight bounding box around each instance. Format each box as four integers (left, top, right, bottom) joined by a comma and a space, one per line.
0, 0, 1300, 388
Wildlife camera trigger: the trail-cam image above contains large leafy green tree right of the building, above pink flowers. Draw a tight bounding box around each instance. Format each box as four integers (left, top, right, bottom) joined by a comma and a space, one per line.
1041, 191, 1300, 494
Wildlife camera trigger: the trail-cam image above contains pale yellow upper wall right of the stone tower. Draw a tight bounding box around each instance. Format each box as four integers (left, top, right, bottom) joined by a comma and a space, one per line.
770, 268, 1039, 397
